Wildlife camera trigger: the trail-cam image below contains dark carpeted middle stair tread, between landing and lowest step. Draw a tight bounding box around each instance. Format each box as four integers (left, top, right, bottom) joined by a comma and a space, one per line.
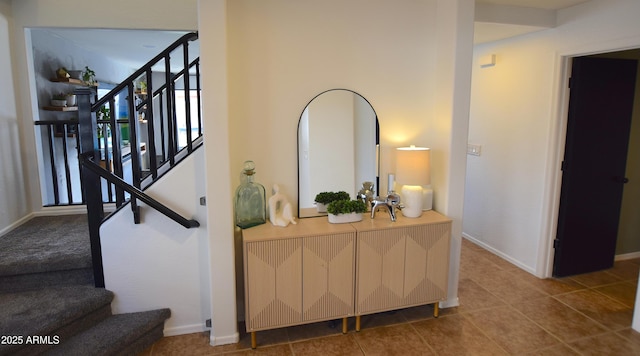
0, 286, 113, 338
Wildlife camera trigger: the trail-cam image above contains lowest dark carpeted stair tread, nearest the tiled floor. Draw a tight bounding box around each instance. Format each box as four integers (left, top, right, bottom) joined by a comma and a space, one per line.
46, 309, 171, 355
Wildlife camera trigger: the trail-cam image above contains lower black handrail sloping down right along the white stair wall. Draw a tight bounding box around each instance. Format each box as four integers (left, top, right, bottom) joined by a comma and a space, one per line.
80, 154, 200, 229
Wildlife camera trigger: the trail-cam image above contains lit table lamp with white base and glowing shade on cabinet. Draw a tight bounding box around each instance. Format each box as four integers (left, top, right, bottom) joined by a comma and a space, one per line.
396, 145, 433, 218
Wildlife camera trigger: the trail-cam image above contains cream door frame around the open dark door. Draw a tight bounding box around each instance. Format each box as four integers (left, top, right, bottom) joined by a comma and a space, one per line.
536, 42, 640, 278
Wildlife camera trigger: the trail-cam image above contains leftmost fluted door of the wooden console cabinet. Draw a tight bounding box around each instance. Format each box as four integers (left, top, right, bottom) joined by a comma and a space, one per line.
244, 239, 302, 331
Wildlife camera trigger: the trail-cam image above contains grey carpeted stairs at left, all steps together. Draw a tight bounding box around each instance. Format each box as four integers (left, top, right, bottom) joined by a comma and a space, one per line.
0, 215, 171, 355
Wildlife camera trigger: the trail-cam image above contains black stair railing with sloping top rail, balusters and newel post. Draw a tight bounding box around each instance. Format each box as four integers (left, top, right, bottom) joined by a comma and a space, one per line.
75, 33, 202, 287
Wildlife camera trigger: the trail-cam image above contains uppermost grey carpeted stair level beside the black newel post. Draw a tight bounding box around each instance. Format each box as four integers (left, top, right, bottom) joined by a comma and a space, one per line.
0, 215, 91, 276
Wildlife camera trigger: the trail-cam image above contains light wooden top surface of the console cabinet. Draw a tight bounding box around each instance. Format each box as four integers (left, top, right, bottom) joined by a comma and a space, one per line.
242, 210, 451, 242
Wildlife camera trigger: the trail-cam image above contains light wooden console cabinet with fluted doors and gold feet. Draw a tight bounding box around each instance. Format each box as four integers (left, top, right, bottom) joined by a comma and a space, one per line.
242, 211, 451, 348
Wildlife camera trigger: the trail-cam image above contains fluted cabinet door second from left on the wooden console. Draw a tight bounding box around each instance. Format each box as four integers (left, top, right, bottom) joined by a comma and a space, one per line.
302, 232, 355, 322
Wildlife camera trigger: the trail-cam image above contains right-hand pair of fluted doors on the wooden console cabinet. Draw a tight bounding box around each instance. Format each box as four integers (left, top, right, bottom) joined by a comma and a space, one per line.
356, 222, 451, 315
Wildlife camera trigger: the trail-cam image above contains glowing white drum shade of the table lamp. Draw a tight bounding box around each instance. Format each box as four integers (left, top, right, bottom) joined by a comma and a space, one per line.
396, 146, 431, 185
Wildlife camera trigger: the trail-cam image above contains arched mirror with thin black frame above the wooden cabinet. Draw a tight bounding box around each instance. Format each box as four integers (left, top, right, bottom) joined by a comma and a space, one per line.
298, 89, 380, 218
